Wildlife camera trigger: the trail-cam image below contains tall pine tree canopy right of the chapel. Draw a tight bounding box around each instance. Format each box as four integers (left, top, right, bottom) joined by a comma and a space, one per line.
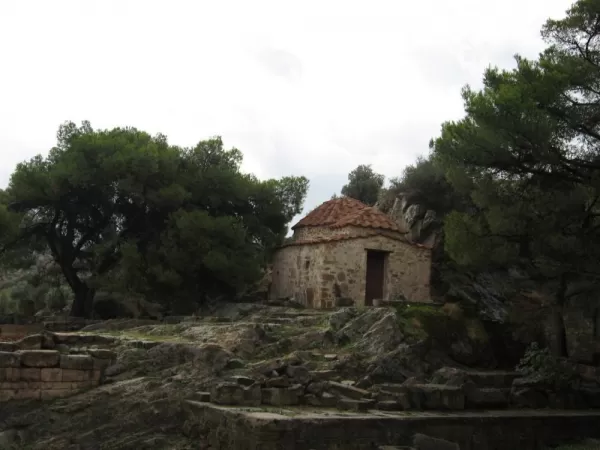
431, 0, 600, 356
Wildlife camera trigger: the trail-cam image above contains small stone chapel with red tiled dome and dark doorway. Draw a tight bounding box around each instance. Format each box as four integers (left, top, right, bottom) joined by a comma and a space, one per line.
269, 197, 431, 308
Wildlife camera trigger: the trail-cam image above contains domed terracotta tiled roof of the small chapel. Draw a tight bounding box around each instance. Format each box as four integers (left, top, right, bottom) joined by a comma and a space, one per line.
292, 197, 402, 232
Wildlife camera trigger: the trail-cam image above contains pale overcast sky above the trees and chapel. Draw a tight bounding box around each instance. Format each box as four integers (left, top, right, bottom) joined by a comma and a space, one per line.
0, 0, 572, 218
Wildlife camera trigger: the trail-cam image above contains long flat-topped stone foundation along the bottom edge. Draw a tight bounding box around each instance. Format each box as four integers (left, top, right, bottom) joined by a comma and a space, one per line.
185, 401, 600, 450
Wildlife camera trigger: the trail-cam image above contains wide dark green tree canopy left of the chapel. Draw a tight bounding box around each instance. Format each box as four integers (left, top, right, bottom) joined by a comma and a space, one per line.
0, 122, 308, 317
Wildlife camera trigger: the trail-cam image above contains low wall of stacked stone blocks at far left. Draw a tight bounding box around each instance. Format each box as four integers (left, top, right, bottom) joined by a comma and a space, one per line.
0, 350, 113, 402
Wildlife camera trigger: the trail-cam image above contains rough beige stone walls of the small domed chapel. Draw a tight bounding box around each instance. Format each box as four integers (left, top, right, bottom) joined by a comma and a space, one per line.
270, 227, 431, 308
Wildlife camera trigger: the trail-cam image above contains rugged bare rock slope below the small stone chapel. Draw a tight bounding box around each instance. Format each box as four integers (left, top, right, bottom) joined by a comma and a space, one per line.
0, 304, 596, 450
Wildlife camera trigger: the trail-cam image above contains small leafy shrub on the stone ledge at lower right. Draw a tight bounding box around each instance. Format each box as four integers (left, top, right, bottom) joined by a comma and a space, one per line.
516, 342, 577, 389
